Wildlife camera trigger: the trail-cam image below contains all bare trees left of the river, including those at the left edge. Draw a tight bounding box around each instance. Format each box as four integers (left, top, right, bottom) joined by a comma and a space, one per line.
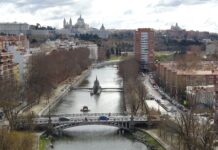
0, 48, 90, 130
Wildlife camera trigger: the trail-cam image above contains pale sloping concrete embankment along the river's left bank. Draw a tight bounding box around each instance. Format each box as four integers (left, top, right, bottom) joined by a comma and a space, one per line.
37, 68, 91, 116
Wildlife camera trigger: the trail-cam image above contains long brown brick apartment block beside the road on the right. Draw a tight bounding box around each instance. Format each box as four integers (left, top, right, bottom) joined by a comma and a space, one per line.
156, 61, 218, 123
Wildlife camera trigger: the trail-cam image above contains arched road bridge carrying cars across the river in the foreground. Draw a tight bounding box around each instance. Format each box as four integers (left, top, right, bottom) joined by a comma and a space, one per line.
34, 113, 148, 130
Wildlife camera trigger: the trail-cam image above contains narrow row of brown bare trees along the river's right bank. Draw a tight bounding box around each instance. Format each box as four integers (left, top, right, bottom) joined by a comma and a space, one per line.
119, 57, 147, 114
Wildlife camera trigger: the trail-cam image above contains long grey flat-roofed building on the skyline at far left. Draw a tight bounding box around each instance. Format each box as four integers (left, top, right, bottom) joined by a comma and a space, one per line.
0, 22, 29, 35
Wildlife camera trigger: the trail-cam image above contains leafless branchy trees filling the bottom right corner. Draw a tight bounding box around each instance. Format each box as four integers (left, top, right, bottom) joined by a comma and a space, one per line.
159, 111, 216, 150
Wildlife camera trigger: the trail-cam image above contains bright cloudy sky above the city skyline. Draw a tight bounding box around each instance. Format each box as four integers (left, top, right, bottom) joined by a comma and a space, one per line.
0, 0, 218, 32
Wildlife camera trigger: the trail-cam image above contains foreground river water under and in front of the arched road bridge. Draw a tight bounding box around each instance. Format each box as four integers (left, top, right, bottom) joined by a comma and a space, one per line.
54, 125, 147, 150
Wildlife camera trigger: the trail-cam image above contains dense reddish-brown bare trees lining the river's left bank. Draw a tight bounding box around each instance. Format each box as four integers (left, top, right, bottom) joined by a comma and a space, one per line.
25, 48, 90, 104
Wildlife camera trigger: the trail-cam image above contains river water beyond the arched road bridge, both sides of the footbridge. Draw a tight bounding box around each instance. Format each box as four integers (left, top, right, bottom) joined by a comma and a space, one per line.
53, 67, 122, 114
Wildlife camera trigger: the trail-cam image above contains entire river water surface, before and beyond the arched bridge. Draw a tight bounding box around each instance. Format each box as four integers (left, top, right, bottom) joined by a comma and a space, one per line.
53, 66, 147, 150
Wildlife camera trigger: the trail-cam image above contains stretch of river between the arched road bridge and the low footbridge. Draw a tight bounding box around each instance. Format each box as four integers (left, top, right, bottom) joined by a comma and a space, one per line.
51, 91, 122, 114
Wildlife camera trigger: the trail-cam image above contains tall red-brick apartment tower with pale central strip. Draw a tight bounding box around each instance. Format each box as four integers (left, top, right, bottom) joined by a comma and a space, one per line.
134, 28, 154, 70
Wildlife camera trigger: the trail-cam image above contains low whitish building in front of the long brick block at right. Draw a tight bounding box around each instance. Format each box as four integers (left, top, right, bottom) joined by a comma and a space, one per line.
186, 85, 215, 108
